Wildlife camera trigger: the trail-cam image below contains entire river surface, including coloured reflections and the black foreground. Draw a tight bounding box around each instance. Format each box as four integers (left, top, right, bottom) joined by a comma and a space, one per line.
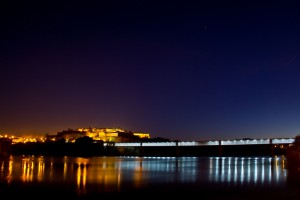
0, 156, 300, 200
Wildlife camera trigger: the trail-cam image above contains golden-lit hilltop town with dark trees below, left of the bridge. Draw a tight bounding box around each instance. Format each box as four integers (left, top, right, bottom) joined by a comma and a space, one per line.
0, 128, 170, 156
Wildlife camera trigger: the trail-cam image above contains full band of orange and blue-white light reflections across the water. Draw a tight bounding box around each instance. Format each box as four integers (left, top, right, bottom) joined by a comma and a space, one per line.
0, 156, 287, 192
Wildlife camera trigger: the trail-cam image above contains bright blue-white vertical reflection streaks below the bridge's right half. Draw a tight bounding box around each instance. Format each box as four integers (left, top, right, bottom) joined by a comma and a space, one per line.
209, 157, 287, 185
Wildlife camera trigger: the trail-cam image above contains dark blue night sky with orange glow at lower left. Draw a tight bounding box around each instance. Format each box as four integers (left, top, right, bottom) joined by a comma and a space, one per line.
0, 0, 300, 141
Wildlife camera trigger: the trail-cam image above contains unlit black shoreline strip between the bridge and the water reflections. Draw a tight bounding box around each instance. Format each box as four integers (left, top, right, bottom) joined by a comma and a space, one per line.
10, 142, 286, 157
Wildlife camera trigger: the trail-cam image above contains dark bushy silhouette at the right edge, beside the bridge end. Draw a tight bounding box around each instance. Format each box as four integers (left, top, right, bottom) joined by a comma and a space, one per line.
286, 135, 300, 170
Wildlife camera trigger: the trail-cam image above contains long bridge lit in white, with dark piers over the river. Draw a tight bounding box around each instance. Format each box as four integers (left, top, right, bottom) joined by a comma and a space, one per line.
104, 138, 295, 156
